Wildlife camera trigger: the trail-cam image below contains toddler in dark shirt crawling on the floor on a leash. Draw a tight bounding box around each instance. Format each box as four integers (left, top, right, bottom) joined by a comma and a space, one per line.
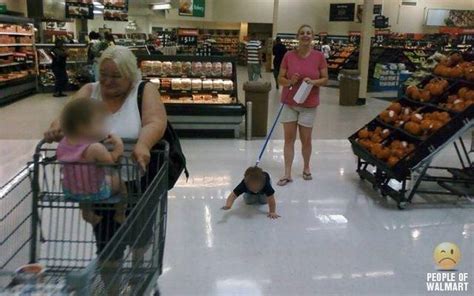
222, 166, 280, 219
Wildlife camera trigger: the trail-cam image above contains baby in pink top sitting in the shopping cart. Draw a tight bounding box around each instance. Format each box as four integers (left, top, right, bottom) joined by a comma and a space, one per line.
56, 99, 127, 225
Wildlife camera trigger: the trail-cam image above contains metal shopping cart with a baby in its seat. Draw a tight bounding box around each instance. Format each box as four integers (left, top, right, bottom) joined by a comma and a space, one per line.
0, 141, 169, 296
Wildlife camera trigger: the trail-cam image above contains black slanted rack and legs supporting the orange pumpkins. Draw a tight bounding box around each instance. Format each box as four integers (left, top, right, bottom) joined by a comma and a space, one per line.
349, 80, 474, 209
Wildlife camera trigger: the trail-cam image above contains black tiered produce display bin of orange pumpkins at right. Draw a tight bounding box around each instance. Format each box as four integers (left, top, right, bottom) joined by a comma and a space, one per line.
349, 56, 474, 209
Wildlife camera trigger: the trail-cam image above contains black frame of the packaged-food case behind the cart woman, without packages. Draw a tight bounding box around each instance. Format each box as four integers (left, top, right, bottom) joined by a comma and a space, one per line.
137, 54, 245, 138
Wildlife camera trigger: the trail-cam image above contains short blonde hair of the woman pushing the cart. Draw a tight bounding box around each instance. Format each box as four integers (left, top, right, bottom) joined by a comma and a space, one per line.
99, 45, 141, 82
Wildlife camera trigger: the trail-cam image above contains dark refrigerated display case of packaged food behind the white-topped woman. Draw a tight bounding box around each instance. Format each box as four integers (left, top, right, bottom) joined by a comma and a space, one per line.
138, 55, 245, 137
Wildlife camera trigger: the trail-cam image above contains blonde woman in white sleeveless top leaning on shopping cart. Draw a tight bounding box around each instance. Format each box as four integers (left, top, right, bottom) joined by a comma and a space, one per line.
45, 46, 167, 295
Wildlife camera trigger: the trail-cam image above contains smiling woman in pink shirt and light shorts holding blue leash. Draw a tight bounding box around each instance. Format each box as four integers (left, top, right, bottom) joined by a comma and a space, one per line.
277, 25, 328, 186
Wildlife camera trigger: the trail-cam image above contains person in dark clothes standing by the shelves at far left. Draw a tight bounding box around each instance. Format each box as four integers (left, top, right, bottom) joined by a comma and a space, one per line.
51, 38, 68, 97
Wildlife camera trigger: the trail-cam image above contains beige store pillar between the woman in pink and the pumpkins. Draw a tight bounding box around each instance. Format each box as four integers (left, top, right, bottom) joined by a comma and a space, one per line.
359, 0, 374, 99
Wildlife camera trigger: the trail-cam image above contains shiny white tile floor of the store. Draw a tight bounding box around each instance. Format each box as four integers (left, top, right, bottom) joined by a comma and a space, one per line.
0, 67, 474, 296
